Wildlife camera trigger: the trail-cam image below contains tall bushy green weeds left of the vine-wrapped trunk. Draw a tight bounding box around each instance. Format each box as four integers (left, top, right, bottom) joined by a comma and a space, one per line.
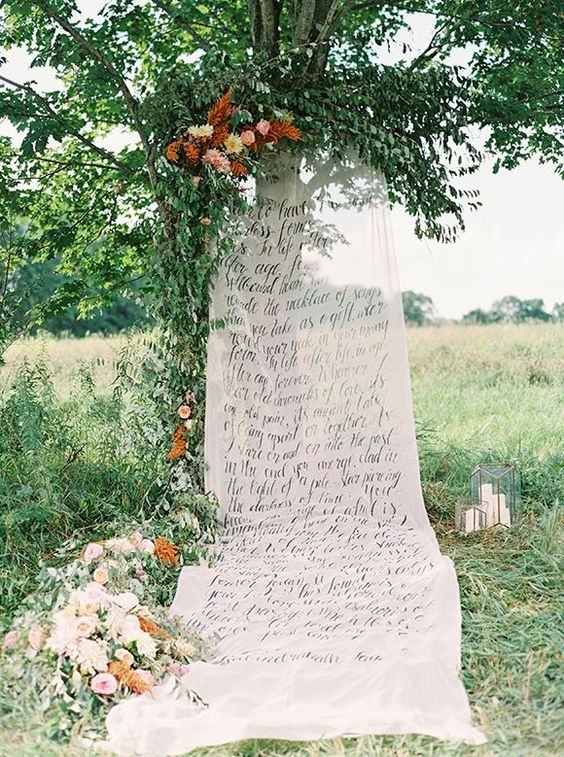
0, 360, 214, 613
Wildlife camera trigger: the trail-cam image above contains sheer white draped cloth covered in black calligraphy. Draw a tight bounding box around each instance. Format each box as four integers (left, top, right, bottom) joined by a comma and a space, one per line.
108, 158, 485, 755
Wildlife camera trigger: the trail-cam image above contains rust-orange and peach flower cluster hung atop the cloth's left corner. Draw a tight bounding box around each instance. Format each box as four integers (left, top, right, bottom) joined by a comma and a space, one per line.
165, 90, 302, 185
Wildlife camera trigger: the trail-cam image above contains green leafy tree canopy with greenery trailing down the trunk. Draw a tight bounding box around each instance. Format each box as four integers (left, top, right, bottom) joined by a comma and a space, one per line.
0, 0, 562, 496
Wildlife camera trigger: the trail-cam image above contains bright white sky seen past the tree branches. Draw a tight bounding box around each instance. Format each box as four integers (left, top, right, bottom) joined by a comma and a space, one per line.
0, 8, 564, 318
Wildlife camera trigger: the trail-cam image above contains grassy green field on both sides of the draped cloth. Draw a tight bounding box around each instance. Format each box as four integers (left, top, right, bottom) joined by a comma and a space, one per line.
0, 325, 564, 757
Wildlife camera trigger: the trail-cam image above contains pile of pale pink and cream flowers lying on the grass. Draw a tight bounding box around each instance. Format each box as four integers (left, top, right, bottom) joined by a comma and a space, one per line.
0, 532, 212, 738
